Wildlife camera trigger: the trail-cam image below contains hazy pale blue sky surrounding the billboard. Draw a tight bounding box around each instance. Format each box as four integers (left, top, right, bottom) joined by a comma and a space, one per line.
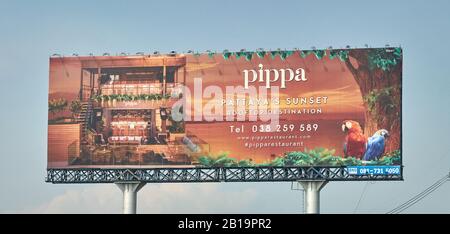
0, 0, 450, 213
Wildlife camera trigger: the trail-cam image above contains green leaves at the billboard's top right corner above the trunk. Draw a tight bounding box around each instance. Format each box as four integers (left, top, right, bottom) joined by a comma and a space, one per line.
369, 48, 402, 71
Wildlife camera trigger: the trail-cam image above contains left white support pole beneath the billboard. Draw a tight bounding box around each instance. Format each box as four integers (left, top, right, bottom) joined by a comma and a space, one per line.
116, 182, 145, 214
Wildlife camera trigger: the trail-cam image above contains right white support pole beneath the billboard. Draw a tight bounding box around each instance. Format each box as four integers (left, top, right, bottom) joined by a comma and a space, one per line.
298, 180, 328, 214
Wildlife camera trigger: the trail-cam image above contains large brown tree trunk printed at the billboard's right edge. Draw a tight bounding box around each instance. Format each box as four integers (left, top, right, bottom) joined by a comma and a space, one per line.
345, 49, 402, 153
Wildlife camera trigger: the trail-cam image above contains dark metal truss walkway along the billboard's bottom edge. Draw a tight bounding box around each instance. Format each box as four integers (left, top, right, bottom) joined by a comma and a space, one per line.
45, 167, 403, 184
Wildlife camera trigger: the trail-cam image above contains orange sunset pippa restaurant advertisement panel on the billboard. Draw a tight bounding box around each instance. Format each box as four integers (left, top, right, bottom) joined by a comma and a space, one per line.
48, 48, 402, 174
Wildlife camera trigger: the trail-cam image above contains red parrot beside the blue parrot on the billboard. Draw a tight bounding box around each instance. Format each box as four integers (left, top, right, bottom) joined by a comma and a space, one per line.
342, 120, 367, 159
